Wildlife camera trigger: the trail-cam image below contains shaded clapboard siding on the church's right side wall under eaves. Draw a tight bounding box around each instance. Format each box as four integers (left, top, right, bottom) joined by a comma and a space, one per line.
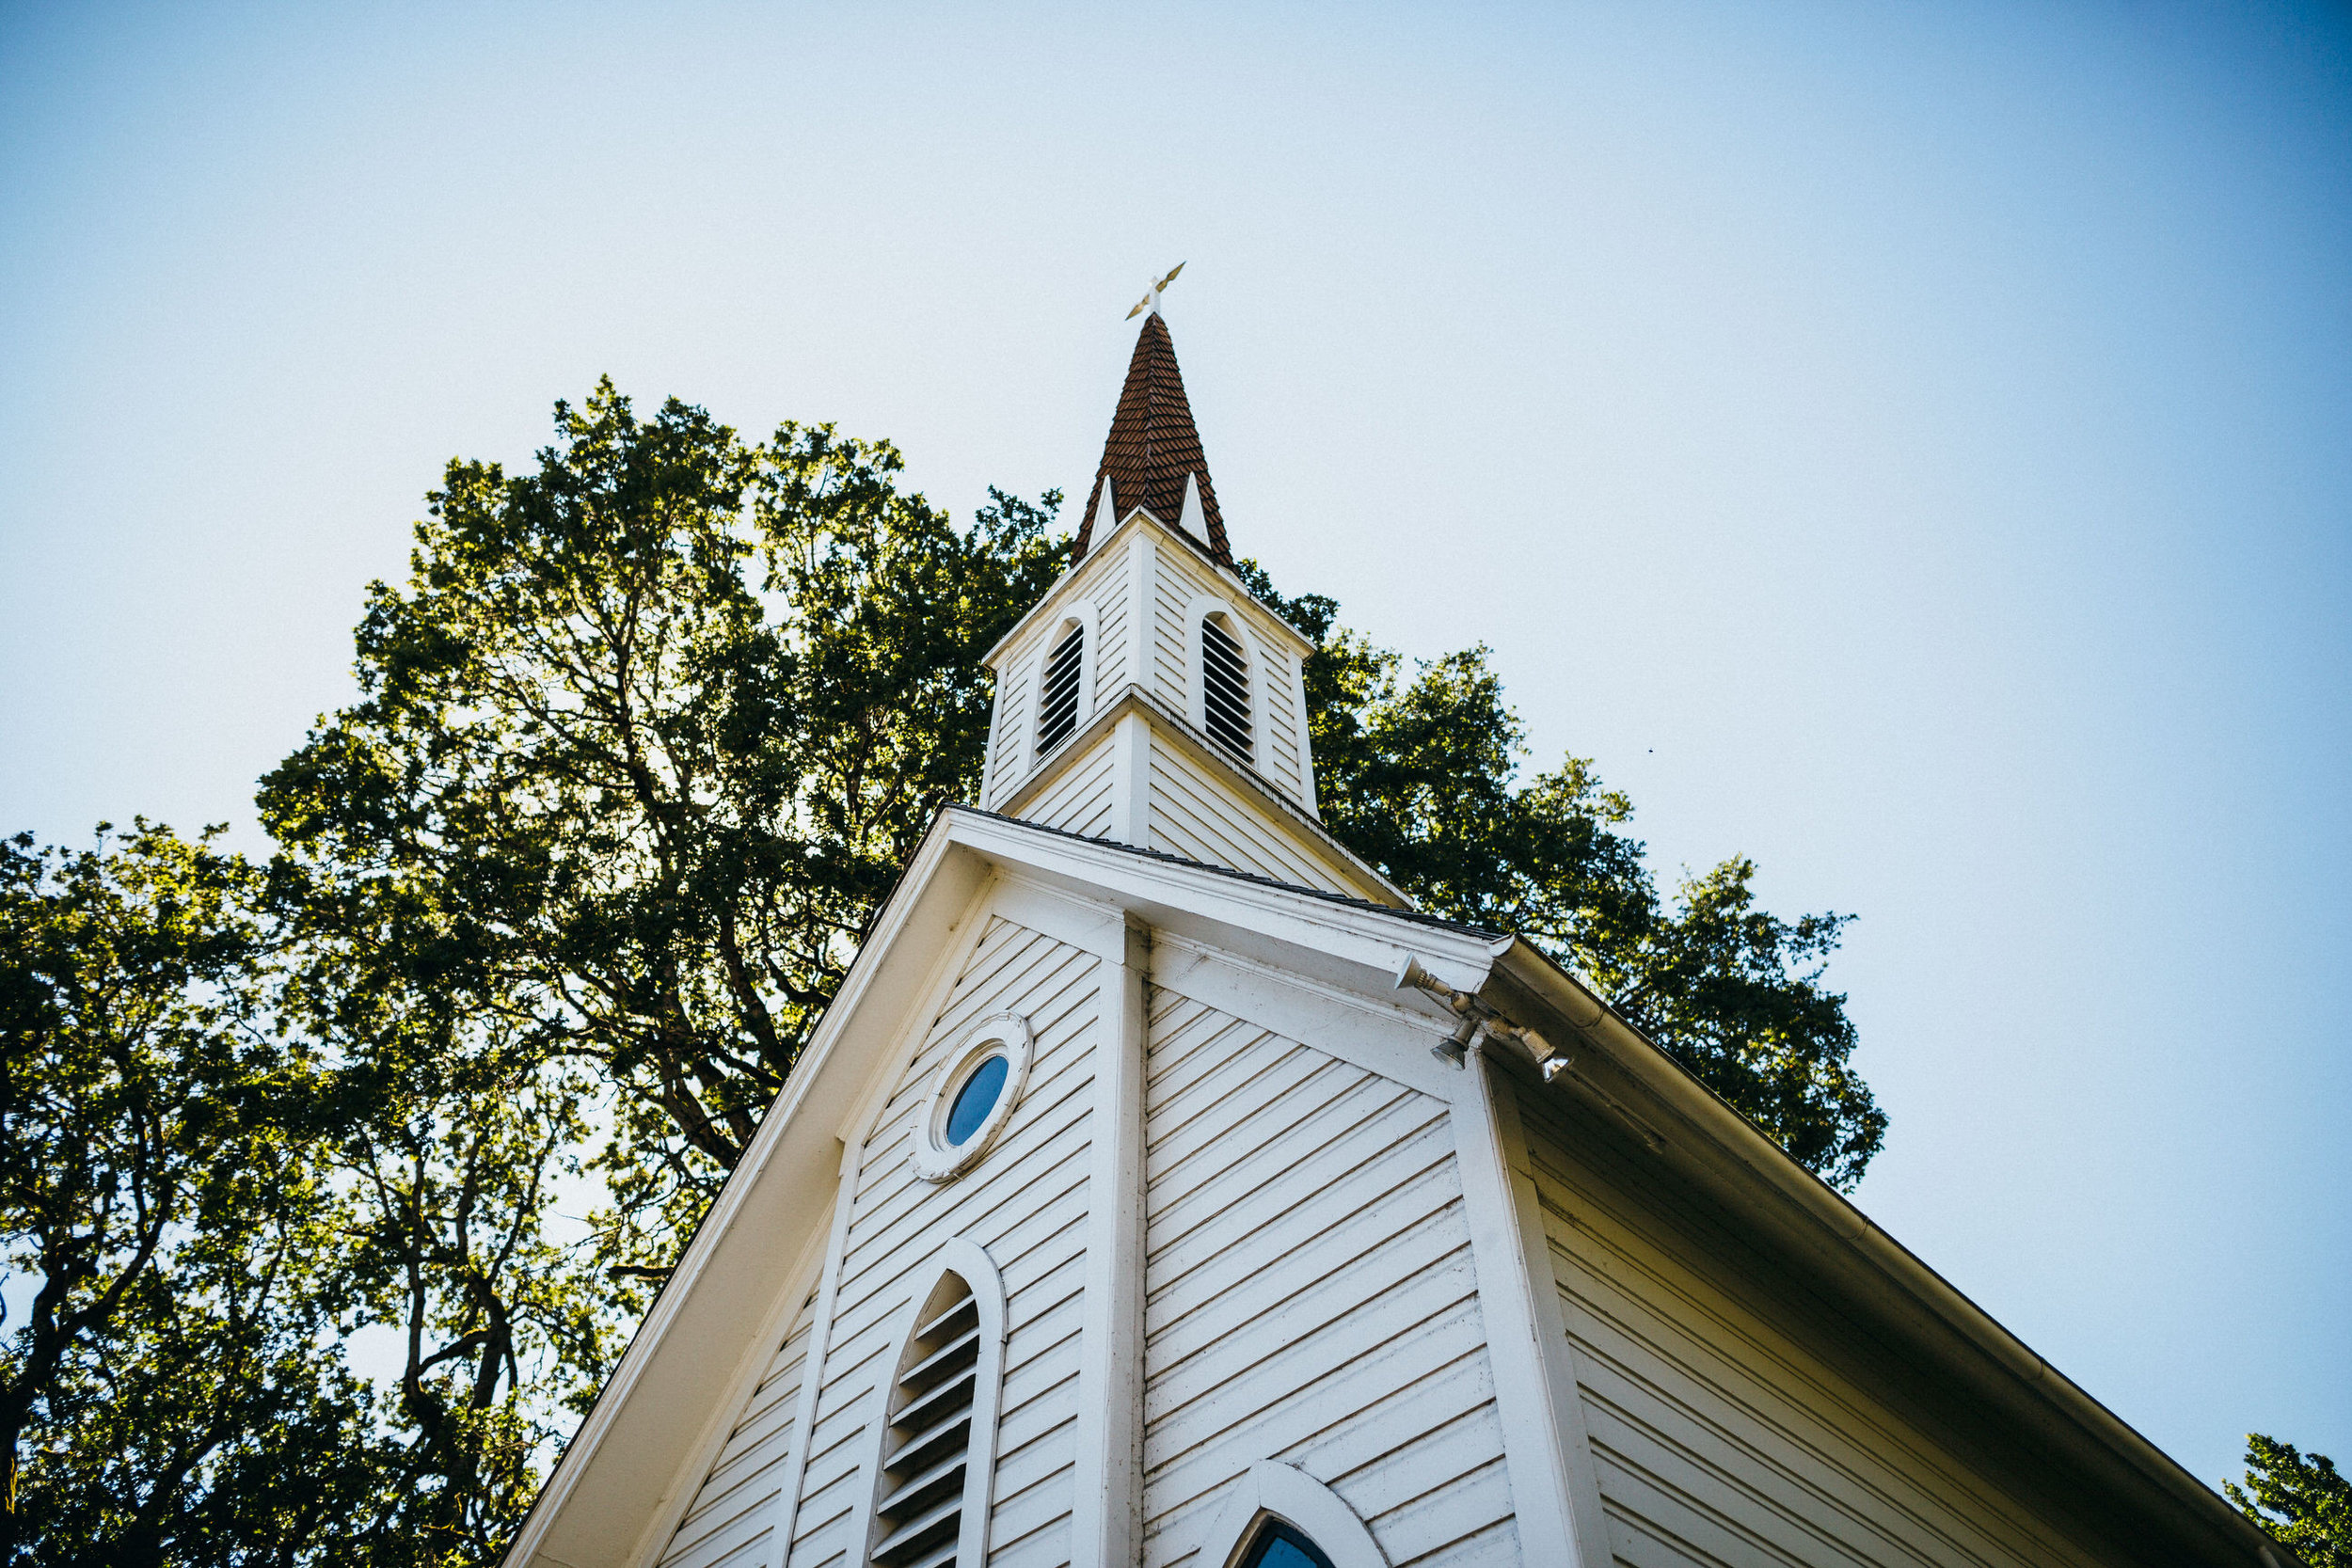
1519, 1093, 2096, 1568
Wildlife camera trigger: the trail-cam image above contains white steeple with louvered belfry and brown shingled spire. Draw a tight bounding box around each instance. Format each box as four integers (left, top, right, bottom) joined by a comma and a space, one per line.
981, 283, 1406, 905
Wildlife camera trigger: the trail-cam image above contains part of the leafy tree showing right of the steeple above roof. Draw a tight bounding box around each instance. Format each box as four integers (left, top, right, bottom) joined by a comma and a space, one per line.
1242, 562, 1886, 1190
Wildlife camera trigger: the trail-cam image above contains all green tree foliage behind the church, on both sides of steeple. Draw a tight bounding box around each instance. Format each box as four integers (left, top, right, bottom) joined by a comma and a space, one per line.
0, 383, 1884, 1568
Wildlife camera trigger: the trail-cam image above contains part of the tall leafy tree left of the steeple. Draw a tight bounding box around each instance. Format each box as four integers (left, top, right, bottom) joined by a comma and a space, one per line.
262, 381, 1063, 1267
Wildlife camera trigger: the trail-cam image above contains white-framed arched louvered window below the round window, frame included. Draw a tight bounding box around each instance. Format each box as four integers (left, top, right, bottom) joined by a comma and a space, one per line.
866, 1237, 1005, 1568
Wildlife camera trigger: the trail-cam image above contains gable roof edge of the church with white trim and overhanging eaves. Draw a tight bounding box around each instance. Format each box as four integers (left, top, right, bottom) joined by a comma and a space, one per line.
506, 806, 2294, 1568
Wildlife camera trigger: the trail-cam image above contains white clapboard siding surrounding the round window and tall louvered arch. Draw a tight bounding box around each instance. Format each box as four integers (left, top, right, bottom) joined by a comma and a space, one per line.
790, 917, 1101, 1568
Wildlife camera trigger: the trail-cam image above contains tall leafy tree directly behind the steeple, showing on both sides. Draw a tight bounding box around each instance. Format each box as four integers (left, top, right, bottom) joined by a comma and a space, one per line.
262, 383, 1884, 1272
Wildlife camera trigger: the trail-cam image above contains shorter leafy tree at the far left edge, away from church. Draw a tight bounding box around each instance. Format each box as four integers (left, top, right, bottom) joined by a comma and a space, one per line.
0, 823, 367, 1566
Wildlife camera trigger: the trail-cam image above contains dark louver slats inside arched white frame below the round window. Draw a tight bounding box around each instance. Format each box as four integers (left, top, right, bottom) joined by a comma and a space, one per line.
873, 1275, 981, 1568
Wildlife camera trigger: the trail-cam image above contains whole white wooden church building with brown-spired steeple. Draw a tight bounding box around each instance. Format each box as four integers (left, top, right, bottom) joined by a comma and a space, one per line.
508, 296, 2291, 1568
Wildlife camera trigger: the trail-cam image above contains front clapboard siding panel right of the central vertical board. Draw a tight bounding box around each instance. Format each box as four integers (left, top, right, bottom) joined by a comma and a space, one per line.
1143, 990, 1519, 1568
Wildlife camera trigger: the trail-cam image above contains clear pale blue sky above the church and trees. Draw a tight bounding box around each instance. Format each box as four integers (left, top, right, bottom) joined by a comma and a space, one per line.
0, 0, 2352, 1481
